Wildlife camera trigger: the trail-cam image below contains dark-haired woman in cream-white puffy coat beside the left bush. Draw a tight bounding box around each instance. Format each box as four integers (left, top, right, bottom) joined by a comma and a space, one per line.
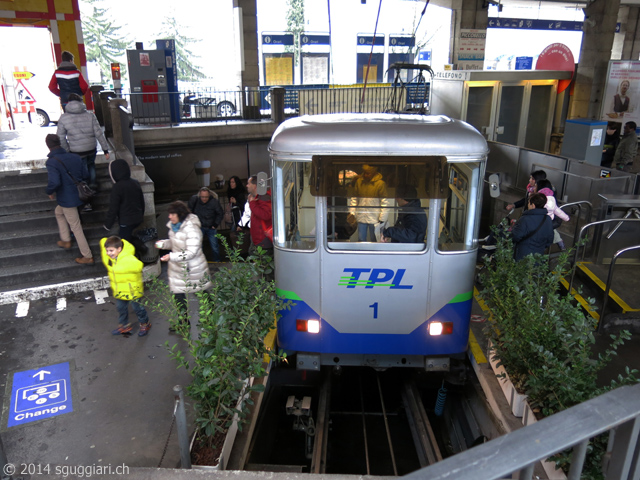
156, 201, 211, 323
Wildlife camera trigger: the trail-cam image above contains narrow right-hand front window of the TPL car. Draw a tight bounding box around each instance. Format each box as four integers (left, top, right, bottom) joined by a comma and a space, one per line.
438, 162, 481, 252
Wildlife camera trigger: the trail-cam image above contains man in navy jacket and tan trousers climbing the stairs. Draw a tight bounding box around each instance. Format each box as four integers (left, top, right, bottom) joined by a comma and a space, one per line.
45, 134, 93, 265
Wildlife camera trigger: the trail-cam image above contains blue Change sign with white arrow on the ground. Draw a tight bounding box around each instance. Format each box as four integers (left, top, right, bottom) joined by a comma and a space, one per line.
7, 362, 73, 427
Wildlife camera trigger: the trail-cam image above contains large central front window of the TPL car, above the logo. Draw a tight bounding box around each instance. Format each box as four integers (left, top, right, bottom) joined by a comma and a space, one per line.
311, 156, 449, 251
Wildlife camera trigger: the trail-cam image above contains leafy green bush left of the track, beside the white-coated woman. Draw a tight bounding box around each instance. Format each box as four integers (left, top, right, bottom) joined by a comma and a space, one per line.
148, 235, 286, 465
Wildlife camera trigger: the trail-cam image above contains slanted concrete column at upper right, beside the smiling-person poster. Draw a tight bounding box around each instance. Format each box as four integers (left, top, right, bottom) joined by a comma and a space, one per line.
568, 0, 620, 118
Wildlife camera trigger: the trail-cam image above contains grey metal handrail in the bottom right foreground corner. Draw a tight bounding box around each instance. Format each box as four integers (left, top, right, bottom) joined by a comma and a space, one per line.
403, 384, 640, 480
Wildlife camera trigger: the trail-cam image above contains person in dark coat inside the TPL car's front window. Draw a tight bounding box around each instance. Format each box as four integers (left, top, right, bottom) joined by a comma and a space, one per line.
382, 185, 427, 243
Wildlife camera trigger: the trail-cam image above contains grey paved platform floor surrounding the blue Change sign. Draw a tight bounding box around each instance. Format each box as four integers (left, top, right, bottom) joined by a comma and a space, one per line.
0, 284, 190, 467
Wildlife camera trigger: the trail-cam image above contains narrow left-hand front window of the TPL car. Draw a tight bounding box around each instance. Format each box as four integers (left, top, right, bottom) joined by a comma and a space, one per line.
273, 162, 316, 250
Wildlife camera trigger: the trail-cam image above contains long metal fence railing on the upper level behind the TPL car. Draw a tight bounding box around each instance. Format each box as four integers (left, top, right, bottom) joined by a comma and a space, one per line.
121, 84, 430, 125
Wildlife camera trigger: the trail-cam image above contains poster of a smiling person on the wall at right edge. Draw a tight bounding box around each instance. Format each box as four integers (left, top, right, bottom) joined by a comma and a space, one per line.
600, 60, 640, 124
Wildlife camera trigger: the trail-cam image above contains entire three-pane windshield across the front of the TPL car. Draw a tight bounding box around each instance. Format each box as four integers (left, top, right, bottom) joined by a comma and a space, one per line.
274, 156, 481, 252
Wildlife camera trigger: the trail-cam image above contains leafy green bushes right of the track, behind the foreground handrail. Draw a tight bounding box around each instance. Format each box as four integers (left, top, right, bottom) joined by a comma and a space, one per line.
481, 231, 638, 478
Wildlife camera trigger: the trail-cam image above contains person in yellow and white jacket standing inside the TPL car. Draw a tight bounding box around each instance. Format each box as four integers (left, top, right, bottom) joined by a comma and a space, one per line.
347, 165, 389, 242
